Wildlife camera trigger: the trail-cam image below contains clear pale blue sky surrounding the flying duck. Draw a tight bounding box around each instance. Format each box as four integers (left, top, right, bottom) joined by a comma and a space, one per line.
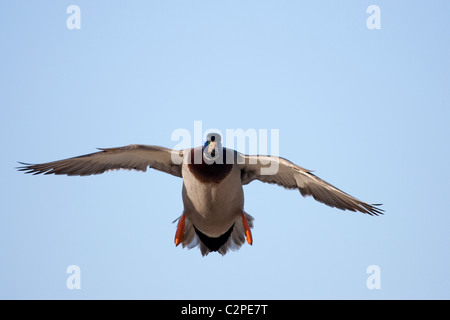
0, 0, 450, 299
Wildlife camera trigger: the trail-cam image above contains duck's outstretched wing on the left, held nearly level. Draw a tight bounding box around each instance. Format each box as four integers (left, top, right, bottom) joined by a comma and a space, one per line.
17, 144, 182, 177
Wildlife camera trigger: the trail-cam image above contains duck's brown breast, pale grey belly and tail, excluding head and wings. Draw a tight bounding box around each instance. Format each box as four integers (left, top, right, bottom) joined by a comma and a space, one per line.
181, 148, 253, 254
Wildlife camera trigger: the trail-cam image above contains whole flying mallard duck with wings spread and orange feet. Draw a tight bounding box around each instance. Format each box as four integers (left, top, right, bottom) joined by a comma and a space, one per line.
17, 133, 383, 256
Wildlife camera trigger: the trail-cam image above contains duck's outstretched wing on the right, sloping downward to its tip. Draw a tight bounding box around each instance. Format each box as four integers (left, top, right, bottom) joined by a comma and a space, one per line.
238, 154, 383, 215
